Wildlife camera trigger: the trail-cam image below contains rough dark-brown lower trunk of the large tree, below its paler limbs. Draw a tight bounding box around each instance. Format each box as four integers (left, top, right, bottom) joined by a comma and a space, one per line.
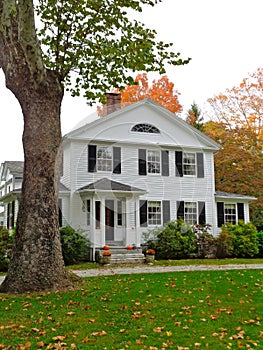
0, 72, 72, 293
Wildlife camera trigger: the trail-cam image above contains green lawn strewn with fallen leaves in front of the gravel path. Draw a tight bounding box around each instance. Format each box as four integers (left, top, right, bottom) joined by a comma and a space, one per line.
0, 270, 263, 350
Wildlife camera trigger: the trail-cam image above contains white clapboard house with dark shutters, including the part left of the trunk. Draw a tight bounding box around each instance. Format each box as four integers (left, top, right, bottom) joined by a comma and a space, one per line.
0, 98, 255, 258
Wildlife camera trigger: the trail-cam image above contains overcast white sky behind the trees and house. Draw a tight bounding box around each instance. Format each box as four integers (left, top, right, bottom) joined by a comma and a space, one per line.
0, 0, 263, 163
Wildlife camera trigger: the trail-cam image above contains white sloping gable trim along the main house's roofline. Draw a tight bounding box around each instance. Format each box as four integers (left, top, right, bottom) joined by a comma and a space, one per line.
63, 98, 221, 151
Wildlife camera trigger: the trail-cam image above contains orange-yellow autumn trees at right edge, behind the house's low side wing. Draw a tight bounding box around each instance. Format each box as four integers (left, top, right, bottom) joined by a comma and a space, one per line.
205, 68, 263, 228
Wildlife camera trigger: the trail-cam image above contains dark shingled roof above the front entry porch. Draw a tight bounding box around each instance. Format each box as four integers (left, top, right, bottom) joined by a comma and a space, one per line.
78, 178, 146, 194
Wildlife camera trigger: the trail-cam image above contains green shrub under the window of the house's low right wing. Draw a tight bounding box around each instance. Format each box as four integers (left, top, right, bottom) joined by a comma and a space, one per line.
219, 221, 258, 258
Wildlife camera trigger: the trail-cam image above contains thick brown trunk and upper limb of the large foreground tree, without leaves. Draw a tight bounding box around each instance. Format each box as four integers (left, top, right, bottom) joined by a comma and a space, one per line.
0, 0, 73, 293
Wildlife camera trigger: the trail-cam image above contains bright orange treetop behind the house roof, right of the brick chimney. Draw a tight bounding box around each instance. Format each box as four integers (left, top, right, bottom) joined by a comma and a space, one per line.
98, 73, 182, 116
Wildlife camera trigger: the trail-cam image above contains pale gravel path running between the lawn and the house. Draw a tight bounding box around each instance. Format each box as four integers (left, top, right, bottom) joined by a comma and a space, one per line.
0, 264, 263, 283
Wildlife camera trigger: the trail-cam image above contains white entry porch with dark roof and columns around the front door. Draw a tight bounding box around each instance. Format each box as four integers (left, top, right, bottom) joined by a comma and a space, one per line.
78, 178, 146, 251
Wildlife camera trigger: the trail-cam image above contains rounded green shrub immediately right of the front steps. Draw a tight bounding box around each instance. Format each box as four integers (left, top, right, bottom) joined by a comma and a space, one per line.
147, 219, 195, 259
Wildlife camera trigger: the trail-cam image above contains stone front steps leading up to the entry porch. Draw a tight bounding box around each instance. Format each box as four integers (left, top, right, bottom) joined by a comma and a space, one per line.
95, 246, 145, 265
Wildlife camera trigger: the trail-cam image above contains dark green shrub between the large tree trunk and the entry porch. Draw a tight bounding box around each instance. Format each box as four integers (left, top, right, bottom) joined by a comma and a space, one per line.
60, 226, 89, 265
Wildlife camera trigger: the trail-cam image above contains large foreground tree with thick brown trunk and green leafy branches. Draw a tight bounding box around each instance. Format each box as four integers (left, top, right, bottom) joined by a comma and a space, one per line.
0, 0, 188, 293
